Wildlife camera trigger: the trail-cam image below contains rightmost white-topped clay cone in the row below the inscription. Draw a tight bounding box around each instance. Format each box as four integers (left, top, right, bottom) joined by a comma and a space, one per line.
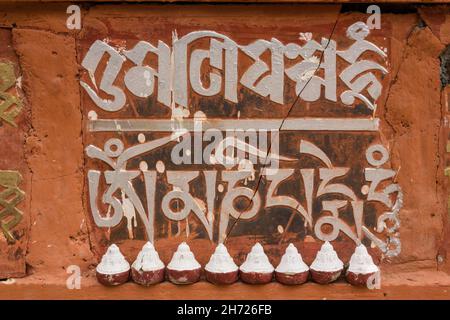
345, 244, 379, 286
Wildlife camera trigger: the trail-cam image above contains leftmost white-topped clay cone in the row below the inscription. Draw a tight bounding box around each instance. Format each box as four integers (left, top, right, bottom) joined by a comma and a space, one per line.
96, 244, 130, 286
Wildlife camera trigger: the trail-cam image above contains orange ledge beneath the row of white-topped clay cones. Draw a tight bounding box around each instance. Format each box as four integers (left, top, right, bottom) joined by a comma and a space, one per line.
0, 271, 450, 300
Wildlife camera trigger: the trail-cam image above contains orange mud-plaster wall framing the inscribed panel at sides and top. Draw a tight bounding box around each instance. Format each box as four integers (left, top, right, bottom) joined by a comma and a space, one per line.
0, 3, 450, 282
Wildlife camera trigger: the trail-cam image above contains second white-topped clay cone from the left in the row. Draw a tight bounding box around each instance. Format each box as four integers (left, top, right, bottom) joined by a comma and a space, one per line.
131, 242, 165, 286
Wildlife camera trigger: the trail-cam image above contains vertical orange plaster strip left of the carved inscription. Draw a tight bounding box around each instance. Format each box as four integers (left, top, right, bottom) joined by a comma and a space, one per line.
13, 28, 92, 282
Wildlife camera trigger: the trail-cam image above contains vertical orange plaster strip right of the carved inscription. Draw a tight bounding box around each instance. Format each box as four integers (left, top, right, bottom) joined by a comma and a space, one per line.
385, 27, 443, 261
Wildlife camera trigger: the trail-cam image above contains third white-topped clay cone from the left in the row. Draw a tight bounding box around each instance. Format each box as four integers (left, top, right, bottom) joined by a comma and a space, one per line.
167, 242, 202, 284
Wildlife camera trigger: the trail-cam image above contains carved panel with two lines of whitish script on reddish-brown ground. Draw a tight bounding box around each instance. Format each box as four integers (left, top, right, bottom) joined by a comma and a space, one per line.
80, 21, 402, 260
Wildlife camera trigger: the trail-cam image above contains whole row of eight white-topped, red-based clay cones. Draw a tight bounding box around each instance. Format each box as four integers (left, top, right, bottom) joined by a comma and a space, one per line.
96, 242, 379, 286
